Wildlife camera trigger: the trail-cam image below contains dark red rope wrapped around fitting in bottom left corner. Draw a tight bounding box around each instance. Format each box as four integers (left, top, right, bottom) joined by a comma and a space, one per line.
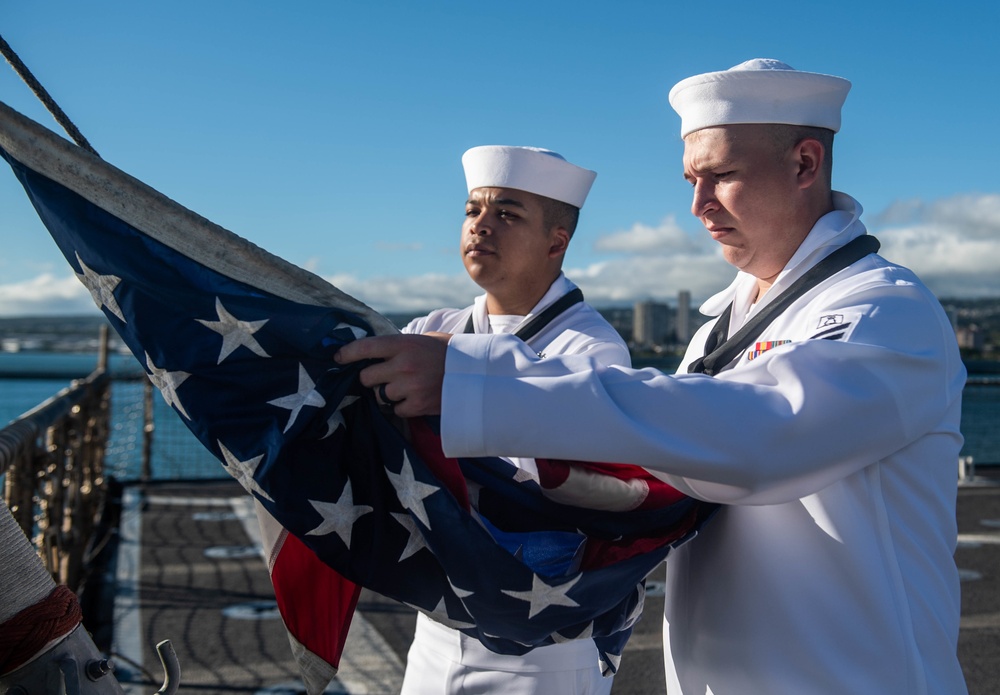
0, 585, 82, 675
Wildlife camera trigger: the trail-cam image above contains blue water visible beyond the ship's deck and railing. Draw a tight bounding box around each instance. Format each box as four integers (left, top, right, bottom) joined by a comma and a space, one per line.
0, 353, 1000, 480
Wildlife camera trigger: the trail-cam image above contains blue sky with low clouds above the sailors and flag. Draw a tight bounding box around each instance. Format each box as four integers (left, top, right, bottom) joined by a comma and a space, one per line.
0, 0, 1000, 316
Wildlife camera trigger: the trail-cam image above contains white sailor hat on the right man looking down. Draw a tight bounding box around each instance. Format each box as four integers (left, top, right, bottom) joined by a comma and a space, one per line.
670, 58, 851, 138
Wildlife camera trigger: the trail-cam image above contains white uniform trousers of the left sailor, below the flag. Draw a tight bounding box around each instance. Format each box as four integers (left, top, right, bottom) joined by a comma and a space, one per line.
401, 613, 614, 695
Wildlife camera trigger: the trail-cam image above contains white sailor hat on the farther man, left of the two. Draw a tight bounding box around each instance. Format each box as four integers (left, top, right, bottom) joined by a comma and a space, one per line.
462, 145, 597, 208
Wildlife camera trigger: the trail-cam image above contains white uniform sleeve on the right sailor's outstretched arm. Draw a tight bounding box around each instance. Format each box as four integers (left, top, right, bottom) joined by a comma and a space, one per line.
442, 287, 964, 504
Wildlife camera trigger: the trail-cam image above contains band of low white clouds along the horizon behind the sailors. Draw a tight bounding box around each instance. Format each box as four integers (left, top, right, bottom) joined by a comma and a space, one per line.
0, 194, 1000, 316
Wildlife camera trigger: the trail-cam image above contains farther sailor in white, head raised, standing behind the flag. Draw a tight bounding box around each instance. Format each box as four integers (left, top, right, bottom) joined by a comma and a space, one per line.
387, 146, 630, 695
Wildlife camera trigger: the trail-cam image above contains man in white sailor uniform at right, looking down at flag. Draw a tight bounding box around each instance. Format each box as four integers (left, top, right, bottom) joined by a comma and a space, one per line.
339, 60, 966, 695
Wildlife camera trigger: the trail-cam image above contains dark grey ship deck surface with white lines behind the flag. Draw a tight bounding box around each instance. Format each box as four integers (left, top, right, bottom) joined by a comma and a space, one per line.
105, 471, 1000, 695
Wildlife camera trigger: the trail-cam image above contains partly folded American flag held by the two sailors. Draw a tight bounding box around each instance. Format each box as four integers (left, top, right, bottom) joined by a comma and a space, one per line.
0, 99, 714, 692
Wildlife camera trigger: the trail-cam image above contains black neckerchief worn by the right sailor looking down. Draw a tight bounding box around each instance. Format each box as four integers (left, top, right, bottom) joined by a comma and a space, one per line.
688, 234, 880, 376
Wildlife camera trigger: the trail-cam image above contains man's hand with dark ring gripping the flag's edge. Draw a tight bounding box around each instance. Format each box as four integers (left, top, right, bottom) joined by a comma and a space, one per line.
334, 333, 451, 417
